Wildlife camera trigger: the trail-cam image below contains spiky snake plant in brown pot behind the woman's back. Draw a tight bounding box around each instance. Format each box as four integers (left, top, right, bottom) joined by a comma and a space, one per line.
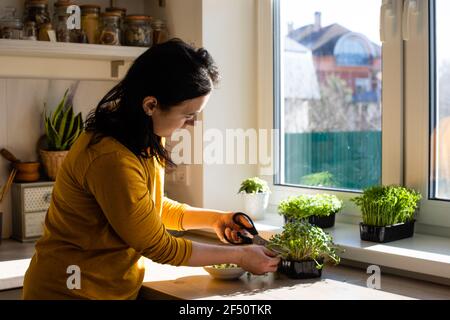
39, 89, 84, 180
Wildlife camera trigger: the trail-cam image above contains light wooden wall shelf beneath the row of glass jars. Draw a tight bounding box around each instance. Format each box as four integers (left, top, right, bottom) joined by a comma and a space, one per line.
0, 39, 148, 80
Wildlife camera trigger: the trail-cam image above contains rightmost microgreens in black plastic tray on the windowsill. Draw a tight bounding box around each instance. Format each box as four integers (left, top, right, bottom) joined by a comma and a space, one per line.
351, 186, 422, 243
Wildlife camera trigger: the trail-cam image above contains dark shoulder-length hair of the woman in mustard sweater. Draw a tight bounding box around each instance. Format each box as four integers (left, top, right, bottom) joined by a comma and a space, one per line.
86, 39, 219, 166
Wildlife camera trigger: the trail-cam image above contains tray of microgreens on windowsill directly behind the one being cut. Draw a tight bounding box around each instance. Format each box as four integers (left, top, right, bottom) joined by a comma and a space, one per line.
278, 194, 342, 228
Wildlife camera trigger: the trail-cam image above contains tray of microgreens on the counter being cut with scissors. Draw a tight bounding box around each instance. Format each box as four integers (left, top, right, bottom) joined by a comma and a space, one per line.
267, 221, 340, 279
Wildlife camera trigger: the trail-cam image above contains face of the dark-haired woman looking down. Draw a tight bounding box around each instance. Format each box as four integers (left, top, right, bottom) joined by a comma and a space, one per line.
144, 94, 210, 138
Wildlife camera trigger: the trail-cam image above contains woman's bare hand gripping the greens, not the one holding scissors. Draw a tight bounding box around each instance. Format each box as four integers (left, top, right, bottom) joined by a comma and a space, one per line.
236, 245, 280, 275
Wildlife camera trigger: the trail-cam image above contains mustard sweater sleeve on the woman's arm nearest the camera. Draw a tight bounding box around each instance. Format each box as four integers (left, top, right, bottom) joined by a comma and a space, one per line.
85, 152, 192, 265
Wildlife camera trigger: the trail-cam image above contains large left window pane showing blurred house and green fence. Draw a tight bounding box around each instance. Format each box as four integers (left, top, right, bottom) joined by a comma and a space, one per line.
276, 0, 382, 190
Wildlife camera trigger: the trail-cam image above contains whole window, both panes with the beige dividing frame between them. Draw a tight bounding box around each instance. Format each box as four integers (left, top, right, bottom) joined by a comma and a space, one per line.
273, 0, 450, 230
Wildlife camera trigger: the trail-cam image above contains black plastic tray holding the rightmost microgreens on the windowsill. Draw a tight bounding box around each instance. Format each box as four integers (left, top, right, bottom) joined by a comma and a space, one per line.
359, 220, 415, 243
